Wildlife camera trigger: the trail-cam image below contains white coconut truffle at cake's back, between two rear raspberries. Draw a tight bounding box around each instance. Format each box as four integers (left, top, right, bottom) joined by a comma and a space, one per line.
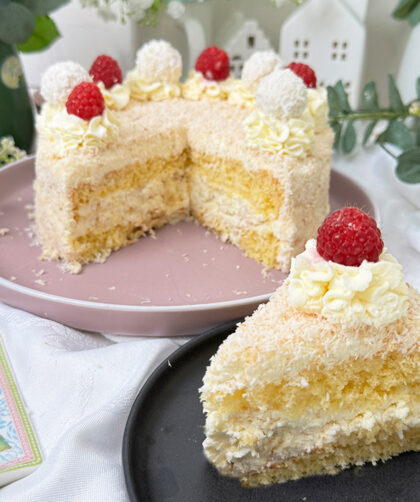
136, 40, 182, 84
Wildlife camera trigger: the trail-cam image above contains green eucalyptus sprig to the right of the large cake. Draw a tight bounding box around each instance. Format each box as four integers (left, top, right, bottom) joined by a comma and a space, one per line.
327, 75, 420, 183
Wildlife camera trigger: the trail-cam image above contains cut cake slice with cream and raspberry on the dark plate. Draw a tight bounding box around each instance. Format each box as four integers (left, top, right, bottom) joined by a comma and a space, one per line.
200, 208, 420, 486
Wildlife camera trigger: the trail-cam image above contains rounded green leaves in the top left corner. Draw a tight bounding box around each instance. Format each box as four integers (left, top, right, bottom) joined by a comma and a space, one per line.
0, 0, 69, 52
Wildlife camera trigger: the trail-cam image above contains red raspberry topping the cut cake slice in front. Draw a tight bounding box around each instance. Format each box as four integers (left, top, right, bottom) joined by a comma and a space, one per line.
316, 207, 384, 267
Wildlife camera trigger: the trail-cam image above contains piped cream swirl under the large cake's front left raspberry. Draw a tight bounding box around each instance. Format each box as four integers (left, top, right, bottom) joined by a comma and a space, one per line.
37, 104, 119, 153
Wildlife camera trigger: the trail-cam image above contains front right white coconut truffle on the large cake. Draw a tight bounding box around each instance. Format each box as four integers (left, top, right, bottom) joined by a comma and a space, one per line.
256, 69, 308, 118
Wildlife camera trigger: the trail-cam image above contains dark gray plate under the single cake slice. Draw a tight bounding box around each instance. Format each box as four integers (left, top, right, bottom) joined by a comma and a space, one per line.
123, 323, 420, 502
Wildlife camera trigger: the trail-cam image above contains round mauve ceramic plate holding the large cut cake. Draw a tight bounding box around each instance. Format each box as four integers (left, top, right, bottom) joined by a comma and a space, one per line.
0, 157, 378, 336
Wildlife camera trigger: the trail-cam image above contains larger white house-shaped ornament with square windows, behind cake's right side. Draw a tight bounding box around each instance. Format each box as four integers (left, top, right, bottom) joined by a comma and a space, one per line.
280, 0, 366, 106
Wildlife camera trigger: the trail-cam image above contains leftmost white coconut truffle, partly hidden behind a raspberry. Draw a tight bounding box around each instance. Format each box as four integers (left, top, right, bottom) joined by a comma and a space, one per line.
41, 61, 92, 106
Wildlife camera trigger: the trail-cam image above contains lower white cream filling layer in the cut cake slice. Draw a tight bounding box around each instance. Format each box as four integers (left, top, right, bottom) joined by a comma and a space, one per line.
203, 400, 420, 476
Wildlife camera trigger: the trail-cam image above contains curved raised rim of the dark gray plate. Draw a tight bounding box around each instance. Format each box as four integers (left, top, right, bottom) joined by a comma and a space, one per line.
121, 317, 240, 502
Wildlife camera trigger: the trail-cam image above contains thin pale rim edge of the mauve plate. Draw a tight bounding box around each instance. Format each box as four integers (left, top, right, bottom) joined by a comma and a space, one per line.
0, 154, 381, 313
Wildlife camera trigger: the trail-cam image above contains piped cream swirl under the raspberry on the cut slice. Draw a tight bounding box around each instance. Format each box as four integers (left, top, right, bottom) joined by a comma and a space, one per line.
287, 239, 408, 327
